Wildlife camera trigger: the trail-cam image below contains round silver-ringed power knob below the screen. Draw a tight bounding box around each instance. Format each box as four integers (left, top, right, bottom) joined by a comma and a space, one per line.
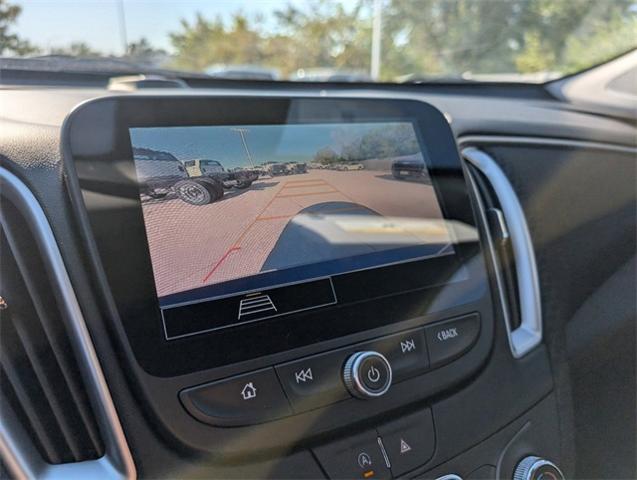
343, 351, 392, 398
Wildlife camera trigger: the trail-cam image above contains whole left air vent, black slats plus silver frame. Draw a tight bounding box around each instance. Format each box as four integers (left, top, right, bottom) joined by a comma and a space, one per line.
0, 168, 134, 478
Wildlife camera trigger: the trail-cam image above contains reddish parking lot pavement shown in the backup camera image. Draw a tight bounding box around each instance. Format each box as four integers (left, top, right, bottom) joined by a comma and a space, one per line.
142, 170, 441, 296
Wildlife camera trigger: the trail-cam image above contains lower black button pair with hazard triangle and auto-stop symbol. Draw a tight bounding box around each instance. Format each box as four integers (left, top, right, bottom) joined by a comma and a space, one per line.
314, 409, 435, 479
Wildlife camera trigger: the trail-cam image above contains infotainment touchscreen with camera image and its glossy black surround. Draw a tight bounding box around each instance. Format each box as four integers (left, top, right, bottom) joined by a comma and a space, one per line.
64, 92, 488, 372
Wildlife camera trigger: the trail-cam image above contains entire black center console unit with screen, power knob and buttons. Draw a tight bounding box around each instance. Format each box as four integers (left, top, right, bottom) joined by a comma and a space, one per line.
64, 95, 550, 478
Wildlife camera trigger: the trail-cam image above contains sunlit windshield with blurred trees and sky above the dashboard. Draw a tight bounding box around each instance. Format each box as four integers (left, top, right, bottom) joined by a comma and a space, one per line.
0, 0, 637, 82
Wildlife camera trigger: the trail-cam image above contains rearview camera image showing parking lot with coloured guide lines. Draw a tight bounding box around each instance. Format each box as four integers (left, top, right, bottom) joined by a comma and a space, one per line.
130, 122, 453, 300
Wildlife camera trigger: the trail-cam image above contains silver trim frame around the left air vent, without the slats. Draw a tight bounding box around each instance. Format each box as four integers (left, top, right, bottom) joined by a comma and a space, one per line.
0, 168, 137, 479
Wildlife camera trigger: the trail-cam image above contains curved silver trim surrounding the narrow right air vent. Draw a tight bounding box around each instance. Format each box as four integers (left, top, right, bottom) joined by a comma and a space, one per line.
462, 147, 542, 358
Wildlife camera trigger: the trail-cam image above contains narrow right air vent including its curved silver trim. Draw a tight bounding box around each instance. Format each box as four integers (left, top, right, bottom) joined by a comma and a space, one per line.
462, 148, 542, 358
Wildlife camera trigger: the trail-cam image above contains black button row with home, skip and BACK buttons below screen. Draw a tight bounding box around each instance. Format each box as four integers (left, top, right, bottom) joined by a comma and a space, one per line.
179, 314, 480, 426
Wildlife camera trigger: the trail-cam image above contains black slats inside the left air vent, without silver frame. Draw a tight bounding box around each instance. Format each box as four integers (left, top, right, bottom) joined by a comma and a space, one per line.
0, 202, 104, 464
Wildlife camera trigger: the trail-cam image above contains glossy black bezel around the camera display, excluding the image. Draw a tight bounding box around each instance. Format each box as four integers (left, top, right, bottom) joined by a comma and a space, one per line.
65, 96, 480, 376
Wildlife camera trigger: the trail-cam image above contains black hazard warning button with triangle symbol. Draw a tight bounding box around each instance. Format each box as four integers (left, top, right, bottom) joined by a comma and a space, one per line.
378, 409, 436, 477
